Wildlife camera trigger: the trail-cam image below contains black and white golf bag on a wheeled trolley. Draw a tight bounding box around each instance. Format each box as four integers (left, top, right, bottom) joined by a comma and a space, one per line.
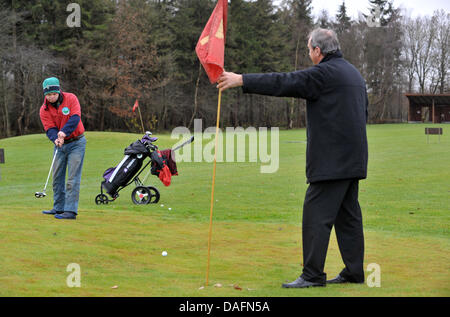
95, 131, 194, 205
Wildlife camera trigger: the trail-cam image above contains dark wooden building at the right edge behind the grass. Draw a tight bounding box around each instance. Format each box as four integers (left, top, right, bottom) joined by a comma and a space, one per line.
405, 94, 450, 123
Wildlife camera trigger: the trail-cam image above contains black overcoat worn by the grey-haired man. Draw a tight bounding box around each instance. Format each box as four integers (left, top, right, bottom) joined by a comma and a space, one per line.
243, 51, 368, 183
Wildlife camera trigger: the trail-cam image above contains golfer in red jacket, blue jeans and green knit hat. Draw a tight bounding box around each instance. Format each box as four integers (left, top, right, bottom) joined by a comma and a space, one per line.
39, 77, 86, 219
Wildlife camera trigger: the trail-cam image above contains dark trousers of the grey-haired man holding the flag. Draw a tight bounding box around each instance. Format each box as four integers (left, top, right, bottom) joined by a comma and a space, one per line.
302, 179, 364, 283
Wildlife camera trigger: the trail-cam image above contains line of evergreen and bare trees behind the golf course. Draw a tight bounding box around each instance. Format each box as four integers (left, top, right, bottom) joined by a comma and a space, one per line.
0, 0, 450, 137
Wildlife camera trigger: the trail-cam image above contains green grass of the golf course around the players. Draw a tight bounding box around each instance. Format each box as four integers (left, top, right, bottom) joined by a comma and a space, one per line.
0, 124, 450, 297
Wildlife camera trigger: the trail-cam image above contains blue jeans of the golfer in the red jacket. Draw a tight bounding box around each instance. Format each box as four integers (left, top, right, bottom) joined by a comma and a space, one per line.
53, 137, 86, 214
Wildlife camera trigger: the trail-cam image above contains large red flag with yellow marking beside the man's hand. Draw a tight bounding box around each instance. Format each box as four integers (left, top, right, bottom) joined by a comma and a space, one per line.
195, 0, 228, 84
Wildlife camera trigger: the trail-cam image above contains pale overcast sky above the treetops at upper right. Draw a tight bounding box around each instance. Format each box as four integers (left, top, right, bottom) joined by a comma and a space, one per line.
275, 0, 450, 19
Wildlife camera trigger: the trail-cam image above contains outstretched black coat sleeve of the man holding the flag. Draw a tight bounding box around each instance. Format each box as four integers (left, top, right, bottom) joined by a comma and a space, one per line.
242, 66, 325, 100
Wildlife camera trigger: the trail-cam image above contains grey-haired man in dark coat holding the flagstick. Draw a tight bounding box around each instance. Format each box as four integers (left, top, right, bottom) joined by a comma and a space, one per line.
217, 28, 368, 288
